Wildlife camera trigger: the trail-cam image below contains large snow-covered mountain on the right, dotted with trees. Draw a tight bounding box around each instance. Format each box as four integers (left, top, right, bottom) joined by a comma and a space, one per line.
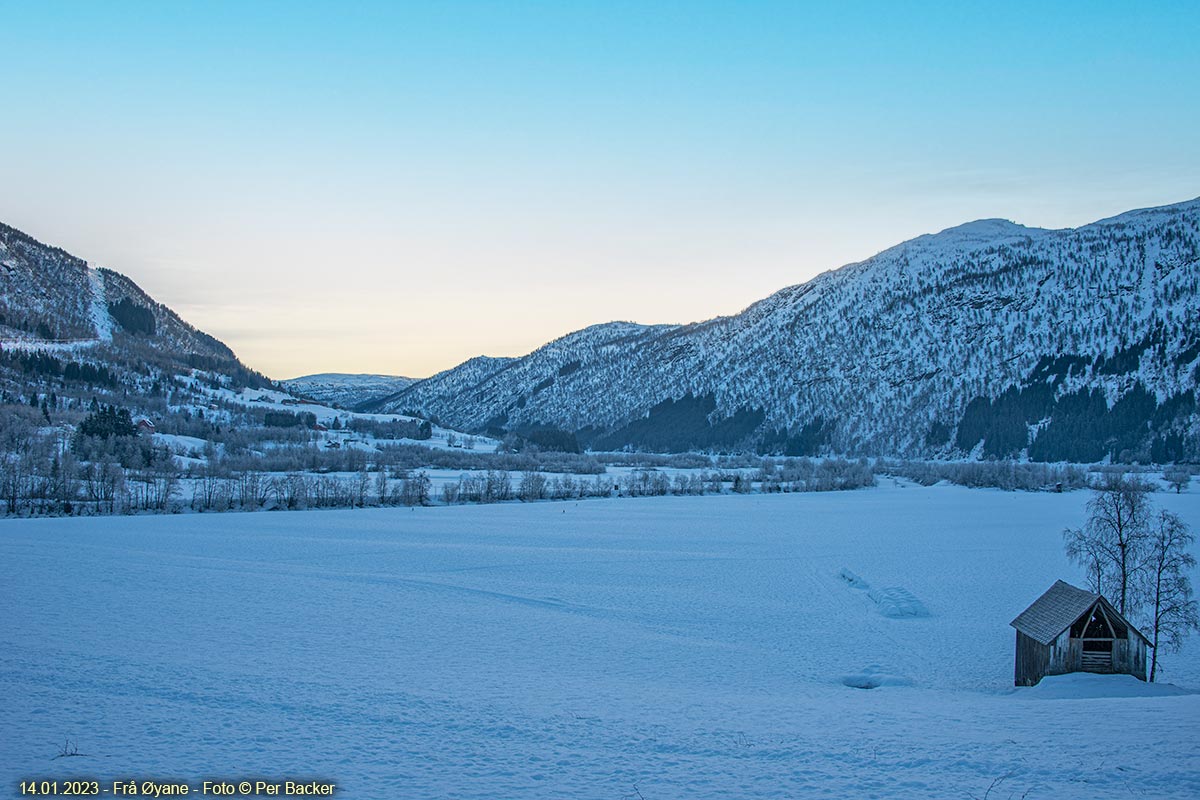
374, 199, 1200, 461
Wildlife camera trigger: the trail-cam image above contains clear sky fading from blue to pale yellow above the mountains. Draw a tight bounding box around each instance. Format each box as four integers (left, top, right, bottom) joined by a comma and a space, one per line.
0, 0, 1200, 378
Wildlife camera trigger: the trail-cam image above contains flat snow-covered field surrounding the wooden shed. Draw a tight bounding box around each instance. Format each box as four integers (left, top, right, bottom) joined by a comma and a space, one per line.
0, 481, 1200, 800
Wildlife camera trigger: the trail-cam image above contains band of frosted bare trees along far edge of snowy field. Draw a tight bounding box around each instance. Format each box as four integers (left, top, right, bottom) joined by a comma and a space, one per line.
0, 417, 1147, 516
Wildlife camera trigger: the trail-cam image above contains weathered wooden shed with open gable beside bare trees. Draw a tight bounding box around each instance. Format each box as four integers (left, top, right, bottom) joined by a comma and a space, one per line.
1012, 581, 1148, 686
